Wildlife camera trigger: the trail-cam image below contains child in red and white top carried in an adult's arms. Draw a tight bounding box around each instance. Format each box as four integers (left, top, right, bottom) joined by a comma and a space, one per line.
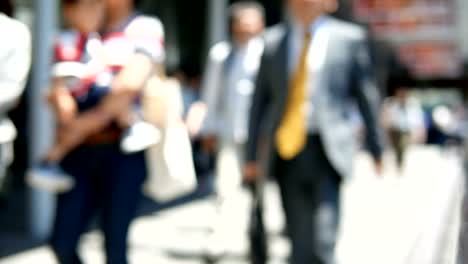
27, 0, 163, 193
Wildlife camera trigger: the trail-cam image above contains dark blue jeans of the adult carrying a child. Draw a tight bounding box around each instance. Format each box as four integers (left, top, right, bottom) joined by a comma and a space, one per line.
51, 144, 146, 264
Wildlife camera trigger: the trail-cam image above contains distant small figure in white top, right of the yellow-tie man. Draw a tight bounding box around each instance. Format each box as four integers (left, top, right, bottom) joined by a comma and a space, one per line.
382, 87, 427, 173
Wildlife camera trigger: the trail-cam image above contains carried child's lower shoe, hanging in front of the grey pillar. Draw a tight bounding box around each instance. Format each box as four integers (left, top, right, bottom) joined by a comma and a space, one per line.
26, 163, 75, 193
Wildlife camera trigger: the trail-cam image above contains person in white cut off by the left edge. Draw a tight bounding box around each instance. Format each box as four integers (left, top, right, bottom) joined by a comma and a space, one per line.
0, 0, 31, 200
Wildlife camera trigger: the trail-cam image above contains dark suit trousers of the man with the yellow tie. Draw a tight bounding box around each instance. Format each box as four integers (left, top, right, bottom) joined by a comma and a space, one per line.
275, 136, 341, 264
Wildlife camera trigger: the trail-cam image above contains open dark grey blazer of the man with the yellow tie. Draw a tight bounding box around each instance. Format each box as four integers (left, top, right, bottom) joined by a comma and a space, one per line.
246, 18, 382, 178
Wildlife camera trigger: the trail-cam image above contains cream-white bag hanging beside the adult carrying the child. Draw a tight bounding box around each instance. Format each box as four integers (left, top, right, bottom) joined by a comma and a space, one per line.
143, 76, 197, 202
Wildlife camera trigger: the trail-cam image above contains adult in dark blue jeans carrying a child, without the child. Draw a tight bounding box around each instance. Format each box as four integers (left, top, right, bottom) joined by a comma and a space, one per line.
45, 0, 164, 263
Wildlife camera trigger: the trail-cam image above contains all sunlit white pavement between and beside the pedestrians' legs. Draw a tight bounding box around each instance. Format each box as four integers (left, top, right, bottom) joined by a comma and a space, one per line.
0, 147, 461, 264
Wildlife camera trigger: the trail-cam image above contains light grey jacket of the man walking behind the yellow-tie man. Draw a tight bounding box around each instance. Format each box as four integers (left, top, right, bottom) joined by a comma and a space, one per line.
201, 38, 263, 144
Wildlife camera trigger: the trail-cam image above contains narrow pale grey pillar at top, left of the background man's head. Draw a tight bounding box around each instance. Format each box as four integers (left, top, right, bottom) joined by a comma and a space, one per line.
206, 0, 229, 50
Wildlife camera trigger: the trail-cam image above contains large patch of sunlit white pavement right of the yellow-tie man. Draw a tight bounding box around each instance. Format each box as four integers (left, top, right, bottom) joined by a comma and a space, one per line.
338, 147, 462, 264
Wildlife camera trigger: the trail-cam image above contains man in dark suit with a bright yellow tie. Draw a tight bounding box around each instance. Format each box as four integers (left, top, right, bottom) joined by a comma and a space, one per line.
244, 0, 382, 264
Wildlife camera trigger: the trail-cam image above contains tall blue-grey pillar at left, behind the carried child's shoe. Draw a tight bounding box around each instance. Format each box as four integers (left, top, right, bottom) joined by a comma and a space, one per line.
29, 0, 58, 239
